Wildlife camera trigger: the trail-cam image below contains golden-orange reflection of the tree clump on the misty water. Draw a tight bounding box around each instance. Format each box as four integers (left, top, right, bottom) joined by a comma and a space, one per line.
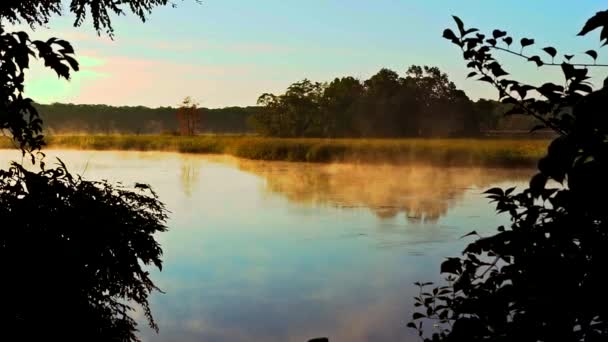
239, 161, 530, 223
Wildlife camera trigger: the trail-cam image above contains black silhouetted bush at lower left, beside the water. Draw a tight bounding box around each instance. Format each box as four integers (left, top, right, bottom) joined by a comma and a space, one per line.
0, 164, 167, 341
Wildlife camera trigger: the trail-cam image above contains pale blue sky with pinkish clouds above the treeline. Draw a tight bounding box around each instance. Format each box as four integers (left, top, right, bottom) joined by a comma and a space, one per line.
16, 0, 608, 108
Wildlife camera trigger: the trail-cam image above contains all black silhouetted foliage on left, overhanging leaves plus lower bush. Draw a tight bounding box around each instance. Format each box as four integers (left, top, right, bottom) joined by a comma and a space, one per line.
0, 0, 183, 341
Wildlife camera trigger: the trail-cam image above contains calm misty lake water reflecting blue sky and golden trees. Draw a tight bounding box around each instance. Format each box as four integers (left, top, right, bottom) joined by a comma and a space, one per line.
0, 151, 527, 341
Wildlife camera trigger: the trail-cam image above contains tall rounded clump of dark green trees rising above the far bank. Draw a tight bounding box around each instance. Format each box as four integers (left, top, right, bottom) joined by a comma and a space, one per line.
251, 66, 529, 137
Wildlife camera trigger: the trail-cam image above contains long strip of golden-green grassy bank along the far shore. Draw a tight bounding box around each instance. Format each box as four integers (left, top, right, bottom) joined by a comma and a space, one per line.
0, 135, 548, 166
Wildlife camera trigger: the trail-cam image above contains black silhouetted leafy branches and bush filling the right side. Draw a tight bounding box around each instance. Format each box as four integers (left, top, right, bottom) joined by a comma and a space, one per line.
408, 11, 608, 342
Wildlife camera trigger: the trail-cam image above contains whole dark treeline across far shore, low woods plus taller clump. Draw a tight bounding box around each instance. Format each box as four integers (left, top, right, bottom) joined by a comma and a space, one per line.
36, 66, 534, 138
